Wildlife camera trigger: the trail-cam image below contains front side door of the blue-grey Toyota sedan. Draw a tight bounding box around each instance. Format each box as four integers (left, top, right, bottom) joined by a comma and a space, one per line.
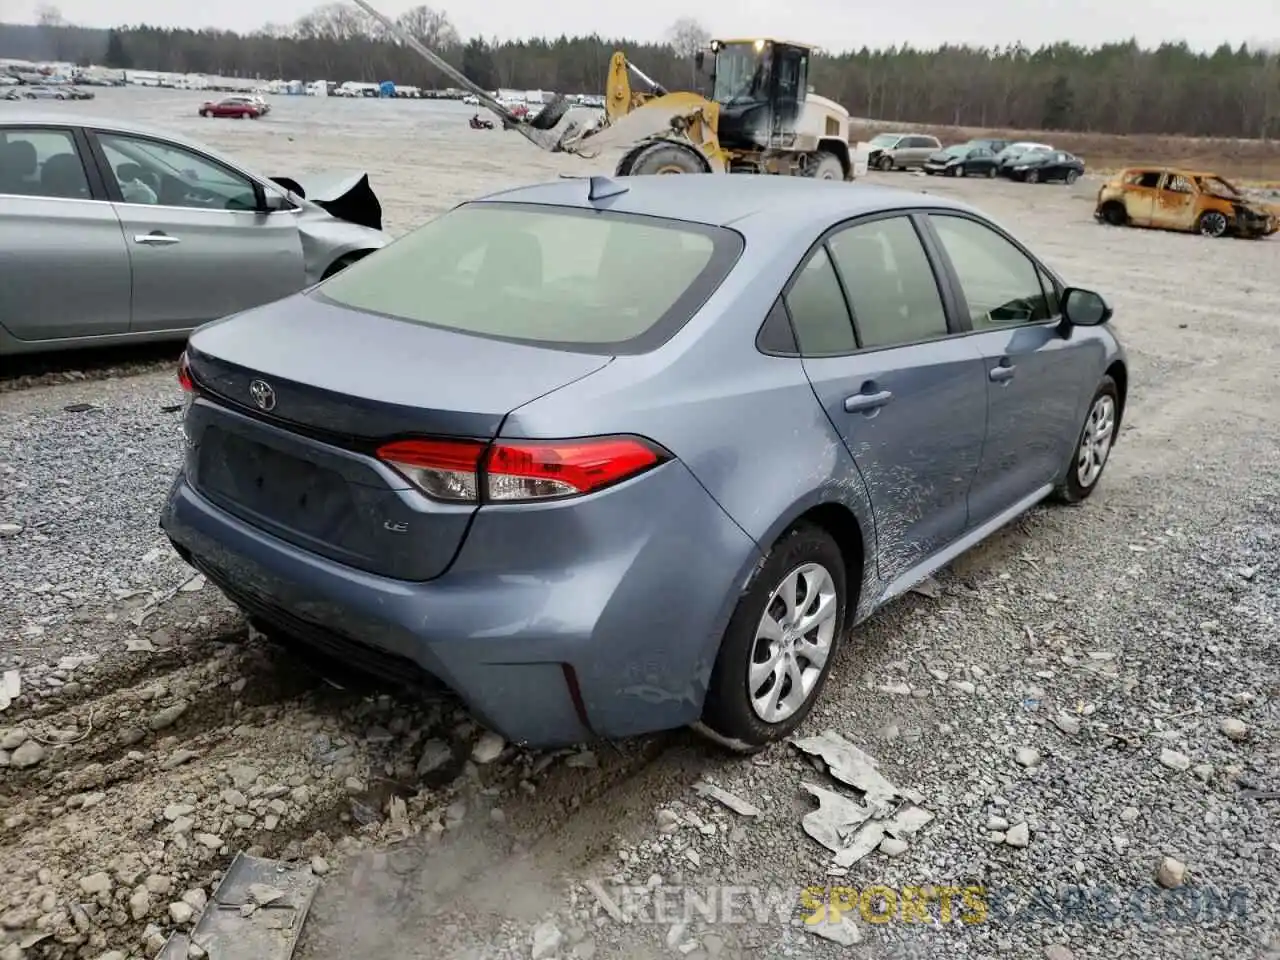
929, 212, 1102, 525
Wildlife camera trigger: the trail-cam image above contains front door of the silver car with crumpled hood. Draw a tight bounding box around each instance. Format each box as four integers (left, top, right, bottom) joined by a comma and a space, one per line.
95, 132, 306, 333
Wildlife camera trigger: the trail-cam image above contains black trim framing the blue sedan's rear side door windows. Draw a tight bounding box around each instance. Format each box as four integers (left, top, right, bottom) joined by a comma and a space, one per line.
755, 206, 972, 360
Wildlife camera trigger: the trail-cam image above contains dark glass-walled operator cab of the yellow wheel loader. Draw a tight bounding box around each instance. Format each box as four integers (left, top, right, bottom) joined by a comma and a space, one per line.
710, 38, 813, 150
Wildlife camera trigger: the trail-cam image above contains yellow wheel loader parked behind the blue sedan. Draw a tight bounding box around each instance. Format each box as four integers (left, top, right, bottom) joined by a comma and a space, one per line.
355, 0, 865, 180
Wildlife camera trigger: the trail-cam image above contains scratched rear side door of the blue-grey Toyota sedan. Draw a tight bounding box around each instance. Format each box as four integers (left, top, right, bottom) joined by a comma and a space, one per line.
786, 214, 987, 581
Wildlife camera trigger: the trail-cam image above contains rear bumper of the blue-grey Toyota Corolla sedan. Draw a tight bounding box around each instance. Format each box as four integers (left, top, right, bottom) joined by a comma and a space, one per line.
160, 462, 759, 748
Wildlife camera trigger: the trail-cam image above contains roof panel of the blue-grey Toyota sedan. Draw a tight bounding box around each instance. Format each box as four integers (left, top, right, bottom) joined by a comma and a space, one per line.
479, 174, 977, 238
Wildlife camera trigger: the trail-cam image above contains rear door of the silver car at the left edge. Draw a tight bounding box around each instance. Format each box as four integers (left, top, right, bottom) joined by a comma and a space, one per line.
0, 125, 131, 340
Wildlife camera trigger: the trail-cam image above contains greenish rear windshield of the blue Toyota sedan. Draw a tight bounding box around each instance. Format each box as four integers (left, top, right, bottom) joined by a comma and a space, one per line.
311, 202, 742, 355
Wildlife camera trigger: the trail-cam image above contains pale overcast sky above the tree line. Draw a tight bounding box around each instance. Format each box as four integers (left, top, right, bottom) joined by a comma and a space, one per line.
0, 0, 1280, 50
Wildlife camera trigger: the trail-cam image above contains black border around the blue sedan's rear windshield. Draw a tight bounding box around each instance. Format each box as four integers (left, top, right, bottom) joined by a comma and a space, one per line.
313, 195, 747, 357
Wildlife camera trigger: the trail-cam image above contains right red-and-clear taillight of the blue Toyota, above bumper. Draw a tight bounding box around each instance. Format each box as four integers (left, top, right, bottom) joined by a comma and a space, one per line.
378, 436, 669, 503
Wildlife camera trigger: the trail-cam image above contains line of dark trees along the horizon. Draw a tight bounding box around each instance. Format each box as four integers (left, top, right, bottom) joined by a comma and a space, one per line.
0, 3, 1280, 138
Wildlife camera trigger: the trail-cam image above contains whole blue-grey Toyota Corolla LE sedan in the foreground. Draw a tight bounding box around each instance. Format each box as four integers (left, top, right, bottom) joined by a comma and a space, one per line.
161, 176, 1129, 751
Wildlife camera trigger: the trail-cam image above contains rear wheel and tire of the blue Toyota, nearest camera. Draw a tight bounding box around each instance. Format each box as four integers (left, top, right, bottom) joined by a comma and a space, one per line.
698, 524, 847, 753
